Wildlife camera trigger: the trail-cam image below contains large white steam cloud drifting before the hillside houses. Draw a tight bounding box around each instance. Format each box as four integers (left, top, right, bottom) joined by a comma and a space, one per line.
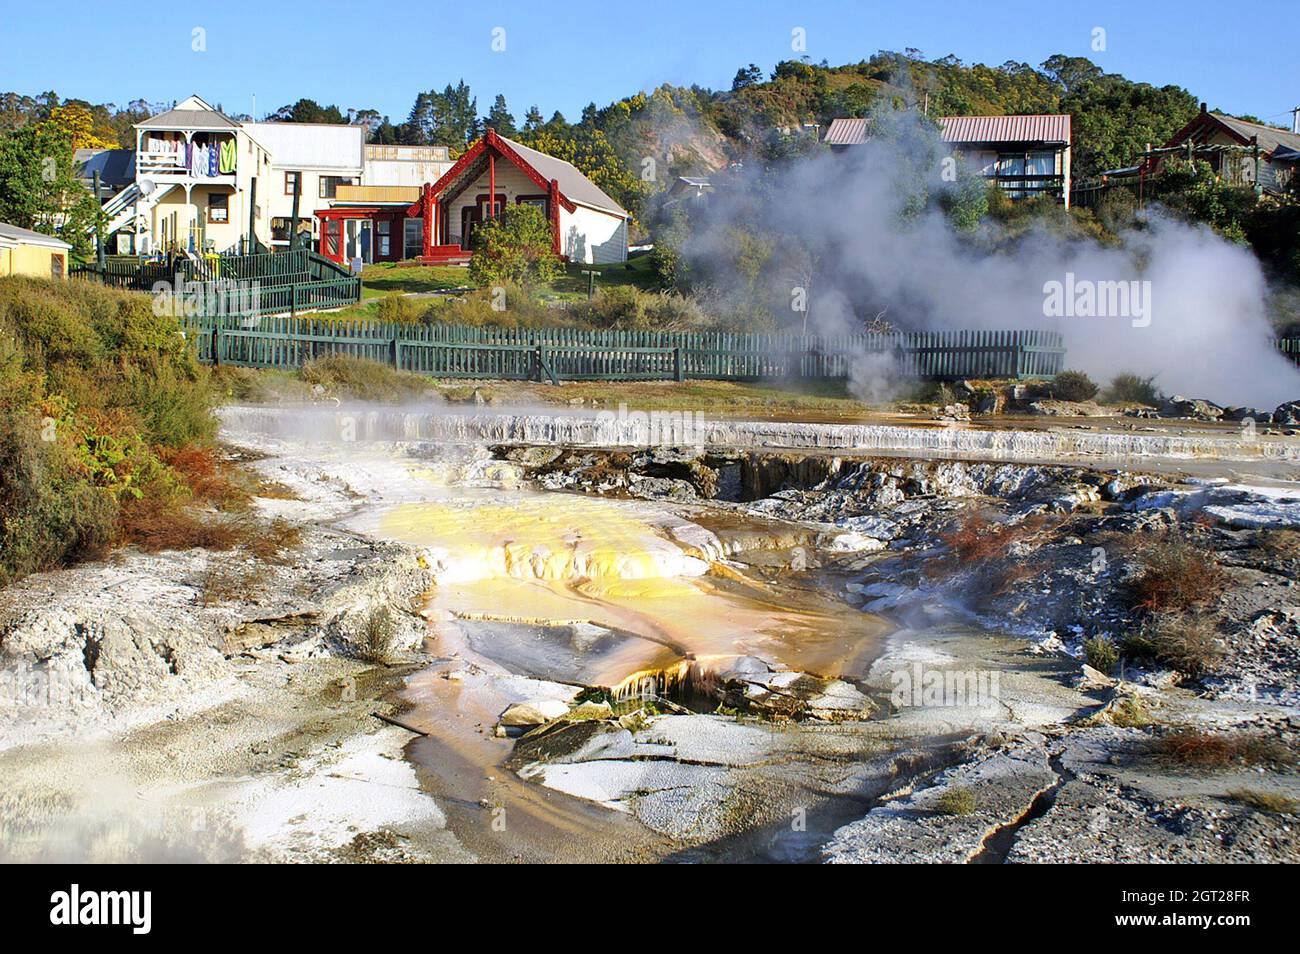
684, 112, 1300, 408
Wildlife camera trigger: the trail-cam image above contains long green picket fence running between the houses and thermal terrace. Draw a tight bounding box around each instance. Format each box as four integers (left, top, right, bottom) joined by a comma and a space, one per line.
185, 316, 1065, 382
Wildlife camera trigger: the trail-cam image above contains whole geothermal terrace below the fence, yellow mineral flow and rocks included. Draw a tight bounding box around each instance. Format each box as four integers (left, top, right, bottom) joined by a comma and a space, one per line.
0, 407, 1300, 862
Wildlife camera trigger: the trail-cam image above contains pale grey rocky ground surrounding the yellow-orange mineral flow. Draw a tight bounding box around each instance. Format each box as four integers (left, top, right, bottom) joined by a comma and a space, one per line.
0, 410, 1300, 863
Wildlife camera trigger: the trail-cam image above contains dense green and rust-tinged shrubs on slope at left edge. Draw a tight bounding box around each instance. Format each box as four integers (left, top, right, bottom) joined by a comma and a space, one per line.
0, 278, 216, 584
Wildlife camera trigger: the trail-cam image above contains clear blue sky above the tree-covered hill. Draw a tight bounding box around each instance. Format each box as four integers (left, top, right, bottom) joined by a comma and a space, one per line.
0, 0, 1300, 122
